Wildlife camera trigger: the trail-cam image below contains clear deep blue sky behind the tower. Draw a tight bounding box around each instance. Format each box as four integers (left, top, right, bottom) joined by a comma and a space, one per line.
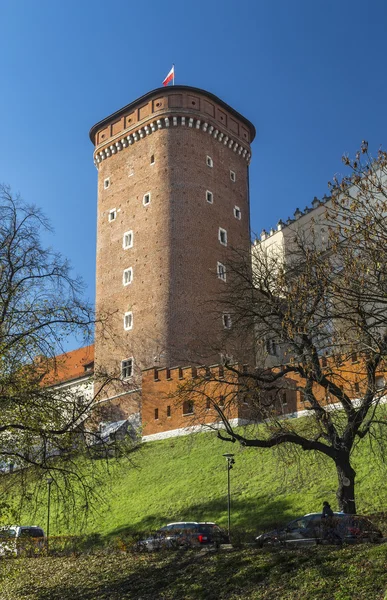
0, 0, 387, 332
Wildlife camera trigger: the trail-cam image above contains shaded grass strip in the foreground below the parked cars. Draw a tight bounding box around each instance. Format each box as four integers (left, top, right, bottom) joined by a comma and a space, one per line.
0, 544, 387, 600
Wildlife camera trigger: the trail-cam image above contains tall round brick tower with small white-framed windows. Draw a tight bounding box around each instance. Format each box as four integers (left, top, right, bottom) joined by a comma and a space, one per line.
90, 85, 255, 379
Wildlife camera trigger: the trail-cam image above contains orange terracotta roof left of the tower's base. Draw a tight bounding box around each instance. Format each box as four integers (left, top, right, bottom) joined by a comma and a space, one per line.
43, 344, 94, 385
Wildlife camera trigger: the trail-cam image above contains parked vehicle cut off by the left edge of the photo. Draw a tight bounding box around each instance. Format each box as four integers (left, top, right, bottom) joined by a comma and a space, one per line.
0, 525, 46, 556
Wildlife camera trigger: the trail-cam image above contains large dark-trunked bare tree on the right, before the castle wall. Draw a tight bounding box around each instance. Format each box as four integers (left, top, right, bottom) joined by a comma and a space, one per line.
177, 142, 387, 513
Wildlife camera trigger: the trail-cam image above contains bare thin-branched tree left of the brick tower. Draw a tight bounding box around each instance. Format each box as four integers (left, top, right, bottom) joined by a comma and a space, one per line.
0, 186, 139, 524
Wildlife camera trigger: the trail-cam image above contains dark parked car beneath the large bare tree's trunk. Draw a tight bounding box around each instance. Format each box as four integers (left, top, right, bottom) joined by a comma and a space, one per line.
255, 512, 383, 547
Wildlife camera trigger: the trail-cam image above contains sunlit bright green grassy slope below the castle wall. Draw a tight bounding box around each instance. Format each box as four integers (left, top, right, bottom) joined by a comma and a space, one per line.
6, 426, 387, 537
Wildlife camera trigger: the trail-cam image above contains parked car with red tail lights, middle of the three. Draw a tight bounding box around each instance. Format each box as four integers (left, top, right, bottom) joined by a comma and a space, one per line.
136, 521, 229, 551
